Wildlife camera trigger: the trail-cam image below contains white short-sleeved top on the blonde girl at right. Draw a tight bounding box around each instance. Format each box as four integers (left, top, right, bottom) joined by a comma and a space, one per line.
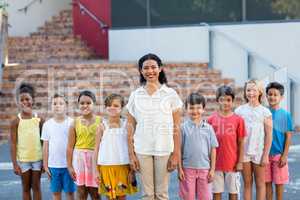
235, 103, 272, 156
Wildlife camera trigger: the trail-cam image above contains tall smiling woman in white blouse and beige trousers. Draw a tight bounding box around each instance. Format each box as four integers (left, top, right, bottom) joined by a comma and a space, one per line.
126, 54, 183, 200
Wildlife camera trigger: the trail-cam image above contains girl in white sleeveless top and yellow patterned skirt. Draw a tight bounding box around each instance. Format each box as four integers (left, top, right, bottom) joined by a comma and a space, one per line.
95, 94, 137, 199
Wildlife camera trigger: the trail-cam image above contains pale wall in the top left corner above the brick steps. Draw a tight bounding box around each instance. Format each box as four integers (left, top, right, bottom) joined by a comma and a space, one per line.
7, 0, 72, 36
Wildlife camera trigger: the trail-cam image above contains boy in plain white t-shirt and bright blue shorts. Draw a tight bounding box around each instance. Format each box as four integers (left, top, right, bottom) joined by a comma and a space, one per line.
42, 94, 75, 200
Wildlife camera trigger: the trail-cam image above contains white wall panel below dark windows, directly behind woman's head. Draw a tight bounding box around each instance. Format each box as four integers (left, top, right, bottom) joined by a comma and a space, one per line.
109, 27, 209, 63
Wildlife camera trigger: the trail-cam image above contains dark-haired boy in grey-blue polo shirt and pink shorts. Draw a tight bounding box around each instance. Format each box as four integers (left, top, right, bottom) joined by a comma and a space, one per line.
178, 93, 218, 200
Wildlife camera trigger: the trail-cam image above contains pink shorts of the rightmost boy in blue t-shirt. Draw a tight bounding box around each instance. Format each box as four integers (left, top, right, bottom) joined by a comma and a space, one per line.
265, 155, 289, 184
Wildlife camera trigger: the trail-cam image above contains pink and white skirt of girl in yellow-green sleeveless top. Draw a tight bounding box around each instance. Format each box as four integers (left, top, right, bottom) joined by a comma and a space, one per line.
73, 149, 98, 188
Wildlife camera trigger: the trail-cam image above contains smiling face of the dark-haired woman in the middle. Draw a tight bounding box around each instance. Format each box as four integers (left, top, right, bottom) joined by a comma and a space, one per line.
141, 60, 161, 82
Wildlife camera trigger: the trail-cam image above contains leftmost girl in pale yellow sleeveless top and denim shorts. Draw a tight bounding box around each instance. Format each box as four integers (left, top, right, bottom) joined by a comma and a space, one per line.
10, 83, 43, 200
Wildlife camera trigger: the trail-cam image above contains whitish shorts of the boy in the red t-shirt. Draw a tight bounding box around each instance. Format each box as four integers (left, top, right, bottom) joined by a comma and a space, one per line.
213, 171, 241, 194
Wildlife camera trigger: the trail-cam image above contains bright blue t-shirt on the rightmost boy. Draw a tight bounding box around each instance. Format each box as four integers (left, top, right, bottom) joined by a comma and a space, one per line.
270, 108, 293, 155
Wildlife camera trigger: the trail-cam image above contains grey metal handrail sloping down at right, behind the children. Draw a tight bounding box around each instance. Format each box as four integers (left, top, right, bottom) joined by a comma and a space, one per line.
200, 23, 300, 116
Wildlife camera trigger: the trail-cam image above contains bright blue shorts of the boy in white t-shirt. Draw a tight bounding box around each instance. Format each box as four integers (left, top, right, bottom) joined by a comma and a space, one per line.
49, 167, 76, 193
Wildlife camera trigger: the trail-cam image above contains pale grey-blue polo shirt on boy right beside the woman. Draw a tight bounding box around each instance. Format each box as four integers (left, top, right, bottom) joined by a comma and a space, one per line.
181, 118, 218, 169
